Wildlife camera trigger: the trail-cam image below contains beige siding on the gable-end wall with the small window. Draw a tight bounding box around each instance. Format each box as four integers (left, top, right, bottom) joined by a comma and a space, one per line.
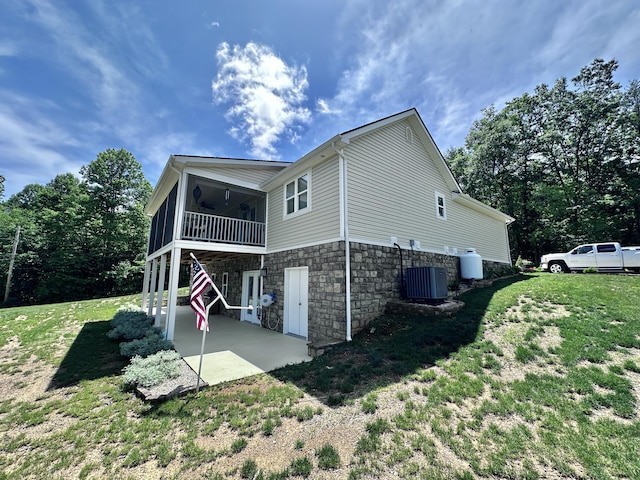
345, 121, 509, 262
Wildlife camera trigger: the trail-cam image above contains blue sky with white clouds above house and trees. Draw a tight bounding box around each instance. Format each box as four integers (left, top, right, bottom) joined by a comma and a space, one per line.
0, 0, 640, 199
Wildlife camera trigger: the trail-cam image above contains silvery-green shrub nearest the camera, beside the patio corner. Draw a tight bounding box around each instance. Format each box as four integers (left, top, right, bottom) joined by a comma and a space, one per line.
122, 350, 181, 388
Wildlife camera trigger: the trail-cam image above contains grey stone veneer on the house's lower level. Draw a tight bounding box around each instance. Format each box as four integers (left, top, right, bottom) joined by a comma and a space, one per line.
200, 241, 510, 344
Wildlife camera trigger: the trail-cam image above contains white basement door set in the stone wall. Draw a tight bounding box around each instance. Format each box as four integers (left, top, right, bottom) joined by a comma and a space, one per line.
283, 267, 309, 339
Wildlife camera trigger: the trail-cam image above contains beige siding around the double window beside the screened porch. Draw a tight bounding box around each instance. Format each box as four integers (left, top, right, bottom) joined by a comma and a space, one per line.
267, 156, 340, 251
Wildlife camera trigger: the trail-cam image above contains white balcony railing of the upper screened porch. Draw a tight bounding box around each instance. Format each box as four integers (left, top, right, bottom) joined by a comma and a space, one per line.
182, 212, 265, 247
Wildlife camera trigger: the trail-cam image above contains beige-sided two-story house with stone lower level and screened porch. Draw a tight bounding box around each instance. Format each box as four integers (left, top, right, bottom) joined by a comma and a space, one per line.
143, 109, 513, 342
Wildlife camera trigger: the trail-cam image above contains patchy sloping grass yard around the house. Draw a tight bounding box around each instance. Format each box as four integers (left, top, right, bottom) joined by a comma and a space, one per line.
0, 274, 640, 480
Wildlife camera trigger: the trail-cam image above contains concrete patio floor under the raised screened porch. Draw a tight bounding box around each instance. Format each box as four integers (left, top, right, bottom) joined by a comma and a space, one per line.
162, 306, 311, 385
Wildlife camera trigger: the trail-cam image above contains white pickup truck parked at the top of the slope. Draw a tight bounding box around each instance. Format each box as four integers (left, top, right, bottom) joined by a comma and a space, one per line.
540, 242, 640, 273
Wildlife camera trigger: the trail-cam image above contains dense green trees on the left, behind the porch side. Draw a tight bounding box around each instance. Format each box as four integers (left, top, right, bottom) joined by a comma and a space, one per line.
0, 149, 152, 306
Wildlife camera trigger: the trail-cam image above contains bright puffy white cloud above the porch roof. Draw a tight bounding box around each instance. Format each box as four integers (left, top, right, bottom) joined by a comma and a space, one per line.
211, 42, 311, 158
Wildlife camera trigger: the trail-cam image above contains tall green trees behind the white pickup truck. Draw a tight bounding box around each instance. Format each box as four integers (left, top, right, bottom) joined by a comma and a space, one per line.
445, 59, 640, 262
